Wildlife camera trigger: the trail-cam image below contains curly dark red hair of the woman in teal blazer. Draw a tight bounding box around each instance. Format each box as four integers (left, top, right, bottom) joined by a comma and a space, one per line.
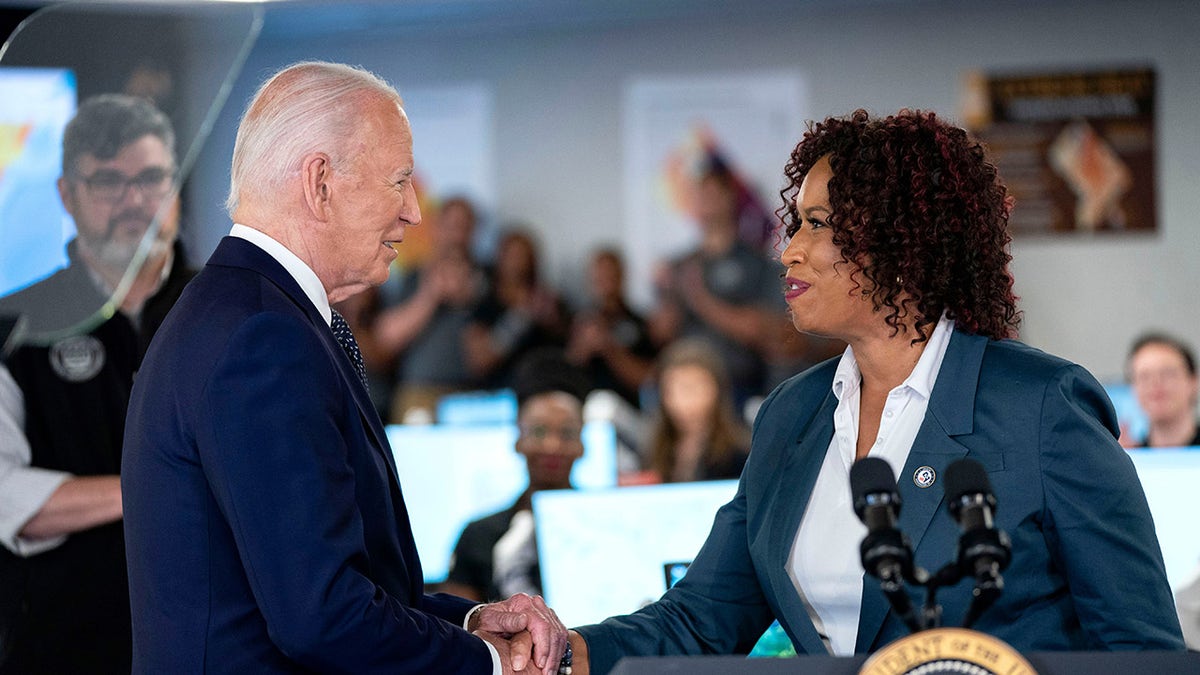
779, 109, 1020, 341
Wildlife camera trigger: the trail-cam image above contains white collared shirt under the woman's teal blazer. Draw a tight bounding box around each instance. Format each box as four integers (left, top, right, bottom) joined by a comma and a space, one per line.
787, 316, 954, 656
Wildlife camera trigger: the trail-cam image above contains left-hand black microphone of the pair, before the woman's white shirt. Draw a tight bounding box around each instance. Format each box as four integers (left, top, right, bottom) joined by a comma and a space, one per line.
850, 458, 925, 633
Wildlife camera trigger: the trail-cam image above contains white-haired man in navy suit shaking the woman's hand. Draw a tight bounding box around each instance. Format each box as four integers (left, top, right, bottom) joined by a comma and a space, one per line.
122, 62, 566, 675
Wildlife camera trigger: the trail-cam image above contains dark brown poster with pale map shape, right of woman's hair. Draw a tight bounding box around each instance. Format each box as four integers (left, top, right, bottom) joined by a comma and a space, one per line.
962, 68, 1157, 235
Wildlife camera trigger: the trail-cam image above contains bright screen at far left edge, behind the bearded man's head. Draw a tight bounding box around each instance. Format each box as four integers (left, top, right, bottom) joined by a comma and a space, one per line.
0, 66, 76, 295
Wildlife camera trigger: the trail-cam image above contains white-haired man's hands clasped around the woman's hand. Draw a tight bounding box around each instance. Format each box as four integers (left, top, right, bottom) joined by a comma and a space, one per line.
467, 593, 566, 675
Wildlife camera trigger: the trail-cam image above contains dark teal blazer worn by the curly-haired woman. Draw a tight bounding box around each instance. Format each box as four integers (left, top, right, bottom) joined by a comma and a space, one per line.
580, 331, 1183, 673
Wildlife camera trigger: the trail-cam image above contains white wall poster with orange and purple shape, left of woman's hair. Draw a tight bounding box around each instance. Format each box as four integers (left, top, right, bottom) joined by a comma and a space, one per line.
623, 71, 805, 307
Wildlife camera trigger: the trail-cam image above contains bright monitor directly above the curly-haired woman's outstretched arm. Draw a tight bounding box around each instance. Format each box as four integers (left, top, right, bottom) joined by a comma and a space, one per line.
533, 480, 738, 626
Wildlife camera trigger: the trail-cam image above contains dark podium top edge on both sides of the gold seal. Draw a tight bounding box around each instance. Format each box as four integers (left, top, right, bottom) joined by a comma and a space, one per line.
612, 651, 1200, 675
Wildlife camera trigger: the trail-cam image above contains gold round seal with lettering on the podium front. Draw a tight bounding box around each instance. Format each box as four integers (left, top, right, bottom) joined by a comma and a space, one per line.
858, 628, 1037, 675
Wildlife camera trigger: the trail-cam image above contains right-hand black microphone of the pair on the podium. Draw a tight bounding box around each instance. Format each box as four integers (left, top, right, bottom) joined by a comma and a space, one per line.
946, 459, 1013, 628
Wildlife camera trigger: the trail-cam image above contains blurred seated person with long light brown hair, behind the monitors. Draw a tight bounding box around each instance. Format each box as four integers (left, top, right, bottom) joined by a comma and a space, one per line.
644, 340, 750, 483
